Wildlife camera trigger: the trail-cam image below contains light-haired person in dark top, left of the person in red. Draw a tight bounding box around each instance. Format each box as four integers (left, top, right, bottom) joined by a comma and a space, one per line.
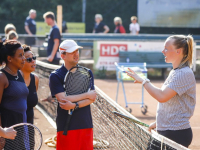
93, 14, 110, 33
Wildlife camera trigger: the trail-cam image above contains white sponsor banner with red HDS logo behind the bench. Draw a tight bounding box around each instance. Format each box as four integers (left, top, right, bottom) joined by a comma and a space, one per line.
94, 41, 164, 71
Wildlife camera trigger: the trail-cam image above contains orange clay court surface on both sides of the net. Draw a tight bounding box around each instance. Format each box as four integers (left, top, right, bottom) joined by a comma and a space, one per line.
34, 79, 200, 150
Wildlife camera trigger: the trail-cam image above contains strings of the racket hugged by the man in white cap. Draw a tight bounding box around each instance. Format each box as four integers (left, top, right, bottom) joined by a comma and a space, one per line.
65, 69, 90, 95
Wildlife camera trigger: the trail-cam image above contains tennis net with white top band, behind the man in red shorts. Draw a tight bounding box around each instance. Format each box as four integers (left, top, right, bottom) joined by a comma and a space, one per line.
35, 61, 187, 150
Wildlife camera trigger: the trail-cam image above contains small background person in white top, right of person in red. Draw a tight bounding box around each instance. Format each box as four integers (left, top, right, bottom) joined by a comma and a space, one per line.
129, 16, 140, 35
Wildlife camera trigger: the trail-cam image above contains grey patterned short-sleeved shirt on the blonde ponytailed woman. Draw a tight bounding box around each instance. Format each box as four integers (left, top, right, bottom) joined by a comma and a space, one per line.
156, 67, 196, 131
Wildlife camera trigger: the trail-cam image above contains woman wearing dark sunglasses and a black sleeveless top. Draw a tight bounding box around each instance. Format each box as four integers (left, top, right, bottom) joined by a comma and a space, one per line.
21, 45, 39, 124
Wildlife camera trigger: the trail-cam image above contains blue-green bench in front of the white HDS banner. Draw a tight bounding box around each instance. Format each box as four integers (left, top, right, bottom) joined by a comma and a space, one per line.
119, 51, 172, 78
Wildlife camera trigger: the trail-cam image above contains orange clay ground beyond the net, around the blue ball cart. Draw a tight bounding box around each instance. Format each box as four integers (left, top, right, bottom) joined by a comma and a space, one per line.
95, 79, 200, 150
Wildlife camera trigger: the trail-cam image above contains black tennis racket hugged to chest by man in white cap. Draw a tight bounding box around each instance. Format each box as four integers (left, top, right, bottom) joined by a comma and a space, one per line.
63, 66, 92, 135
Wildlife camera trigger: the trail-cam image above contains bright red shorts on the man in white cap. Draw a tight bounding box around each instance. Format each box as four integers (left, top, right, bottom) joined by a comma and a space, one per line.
56, 128, 93, 150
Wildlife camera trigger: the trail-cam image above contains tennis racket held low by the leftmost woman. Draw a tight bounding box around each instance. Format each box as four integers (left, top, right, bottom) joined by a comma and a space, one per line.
0, 123, 42, 150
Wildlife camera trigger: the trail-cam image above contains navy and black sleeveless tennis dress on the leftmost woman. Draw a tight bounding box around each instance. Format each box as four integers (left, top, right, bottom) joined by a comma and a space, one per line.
0, 69, 29, 128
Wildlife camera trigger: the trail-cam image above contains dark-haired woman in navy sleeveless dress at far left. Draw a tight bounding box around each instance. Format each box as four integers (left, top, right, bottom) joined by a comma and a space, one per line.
0, 40, 29, 128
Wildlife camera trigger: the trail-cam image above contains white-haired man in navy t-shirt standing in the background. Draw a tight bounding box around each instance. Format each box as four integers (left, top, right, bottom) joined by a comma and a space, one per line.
24, 9, 36, 46
